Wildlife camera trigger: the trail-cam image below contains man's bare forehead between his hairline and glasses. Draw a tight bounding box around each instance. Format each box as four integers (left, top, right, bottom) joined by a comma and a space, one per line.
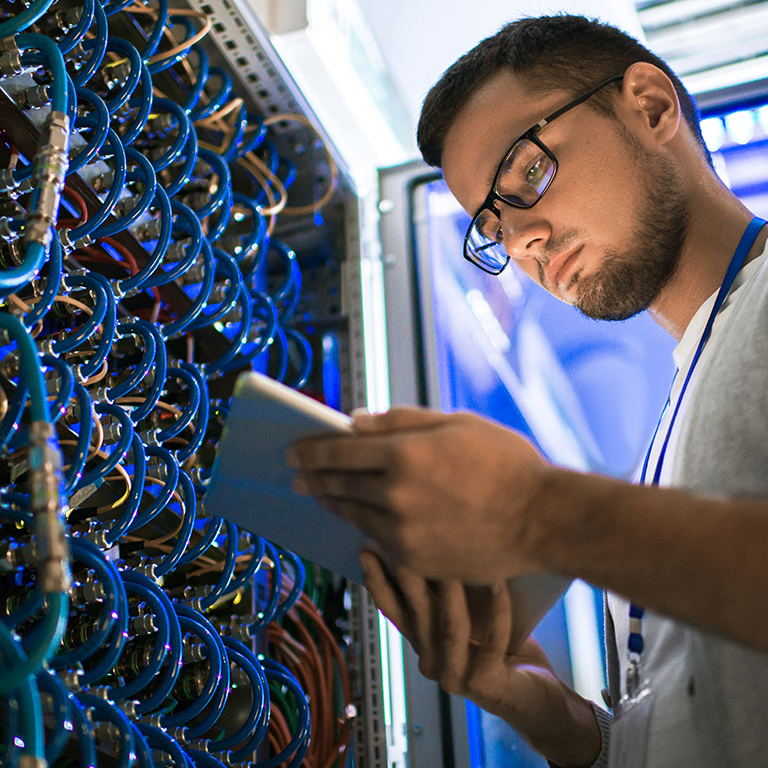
442, 70, 568, 213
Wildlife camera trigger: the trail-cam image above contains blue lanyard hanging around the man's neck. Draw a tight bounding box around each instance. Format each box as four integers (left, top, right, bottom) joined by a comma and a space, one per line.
627, 216, 766, 696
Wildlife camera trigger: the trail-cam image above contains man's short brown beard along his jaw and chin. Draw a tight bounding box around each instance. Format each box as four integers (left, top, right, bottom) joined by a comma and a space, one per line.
571, 145, 689, 320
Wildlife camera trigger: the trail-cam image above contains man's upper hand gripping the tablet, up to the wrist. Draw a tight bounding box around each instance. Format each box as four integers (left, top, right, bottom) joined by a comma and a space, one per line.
288, 408, 552, 583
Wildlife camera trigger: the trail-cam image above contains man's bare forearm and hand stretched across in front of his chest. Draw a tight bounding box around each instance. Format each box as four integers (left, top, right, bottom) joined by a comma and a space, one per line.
291, 409, 768, 650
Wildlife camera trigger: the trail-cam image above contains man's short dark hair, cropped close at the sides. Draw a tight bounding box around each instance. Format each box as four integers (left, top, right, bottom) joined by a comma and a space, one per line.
417, 14, 711, 168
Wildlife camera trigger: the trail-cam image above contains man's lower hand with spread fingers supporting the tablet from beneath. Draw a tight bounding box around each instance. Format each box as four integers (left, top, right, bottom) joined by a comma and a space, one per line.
360, 550, 602, 768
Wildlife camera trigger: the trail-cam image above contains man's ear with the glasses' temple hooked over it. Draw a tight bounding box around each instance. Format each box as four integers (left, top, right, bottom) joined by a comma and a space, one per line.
622, 61, 680, 146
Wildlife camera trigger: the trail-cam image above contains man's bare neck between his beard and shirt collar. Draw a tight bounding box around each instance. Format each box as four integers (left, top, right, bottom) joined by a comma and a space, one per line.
649, 181, 768, 341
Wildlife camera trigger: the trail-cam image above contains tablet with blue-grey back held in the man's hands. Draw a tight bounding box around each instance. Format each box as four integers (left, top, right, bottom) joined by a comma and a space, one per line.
205, 373, 570, 652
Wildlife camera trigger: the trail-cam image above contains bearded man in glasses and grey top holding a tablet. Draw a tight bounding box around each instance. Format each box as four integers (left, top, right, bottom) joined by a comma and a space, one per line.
289, 16, 768, 768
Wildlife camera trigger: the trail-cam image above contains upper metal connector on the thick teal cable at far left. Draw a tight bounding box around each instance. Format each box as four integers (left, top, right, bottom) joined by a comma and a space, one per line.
24, 111, 69, 246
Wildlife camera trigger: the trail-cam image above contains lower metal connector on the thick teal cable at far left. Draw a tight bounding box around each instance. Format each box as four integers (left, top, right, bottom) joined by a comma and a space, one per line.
29, 421, 72, 594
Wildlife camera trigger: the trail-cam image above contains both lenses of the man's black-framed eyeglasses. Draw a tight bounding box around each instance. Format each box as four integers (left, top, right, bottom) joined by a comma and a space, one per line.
466, 139, 555, 273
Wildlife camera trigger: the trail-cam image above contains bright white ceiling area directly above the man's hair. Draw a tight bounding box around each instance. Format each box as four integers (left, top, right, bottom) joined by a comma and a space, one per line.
357, 0, 643, 125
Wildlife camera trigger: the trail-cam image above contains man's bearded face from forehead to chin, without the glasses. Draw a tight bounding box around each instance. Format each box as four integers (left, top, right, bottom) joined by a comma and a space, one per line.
443, 71, 687, 320
